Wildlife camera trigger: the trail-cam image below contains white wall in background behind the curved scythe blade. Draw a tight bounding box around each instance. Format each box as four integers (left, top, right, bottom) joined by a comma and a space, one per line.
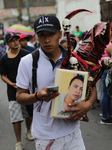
56, 0, 100, 32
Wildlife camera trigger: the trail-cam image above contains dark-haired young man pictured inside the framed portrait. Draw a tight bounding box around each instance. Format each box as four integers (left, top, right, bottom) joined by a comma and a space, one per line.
58, 73, 84, 116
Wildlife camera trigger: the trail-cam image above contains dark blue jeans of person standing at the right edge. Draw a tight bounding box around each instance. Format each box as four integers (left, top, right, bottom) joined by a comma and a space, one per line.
101, 69, 112, 119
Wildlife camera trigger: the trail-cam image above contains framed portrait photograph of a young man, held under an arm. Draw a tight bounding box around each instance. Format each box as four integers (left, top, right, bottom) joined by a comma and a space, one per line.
51, 69, 88, 118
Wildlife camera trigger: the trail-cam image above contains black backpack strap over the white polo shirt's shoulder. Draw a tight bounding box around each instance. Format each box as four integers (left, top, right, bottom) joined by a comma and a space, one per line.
32, 49, 39, 93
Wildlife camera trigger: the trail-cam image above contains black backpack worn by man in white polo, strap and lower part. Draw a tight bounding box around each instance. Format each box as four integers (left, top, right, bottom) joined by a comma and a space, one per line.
26, 49, 39, 117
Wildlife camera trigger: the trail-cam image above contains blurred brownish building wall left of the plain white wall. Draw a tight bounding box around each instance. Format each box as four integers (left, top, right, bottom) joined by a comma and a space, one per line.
0, 0, 56, 33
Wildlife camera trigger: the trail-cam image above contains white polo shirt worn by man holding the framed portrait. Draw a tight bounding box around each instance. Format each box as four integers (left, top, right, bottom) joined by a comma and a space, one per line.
17, 49, 80, 139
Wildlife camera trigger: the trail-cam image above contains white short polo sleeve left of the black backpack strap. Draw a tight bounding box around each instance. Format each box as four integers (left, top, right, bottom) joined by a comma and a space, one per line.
16, 56, 32, 89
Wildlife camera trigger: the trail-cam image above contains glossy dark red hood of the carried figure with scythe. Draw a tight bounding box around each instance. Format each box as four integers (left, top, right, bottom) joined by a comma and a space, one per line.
77, 22, 110, 64
